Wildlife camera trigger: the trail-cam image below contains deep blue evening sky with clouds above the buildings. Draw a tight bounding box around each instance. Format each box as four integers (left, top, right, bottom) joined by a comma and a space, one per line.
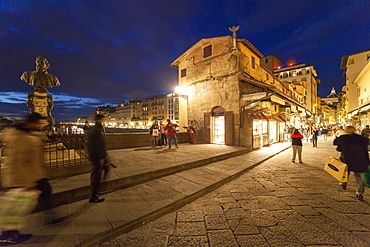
0, 0, 370, 121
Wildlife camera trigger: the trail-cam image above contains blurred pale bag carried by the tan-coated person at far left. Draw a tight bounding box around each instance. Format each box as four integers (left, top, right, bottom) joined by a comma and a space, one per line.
0, 188, 41, 230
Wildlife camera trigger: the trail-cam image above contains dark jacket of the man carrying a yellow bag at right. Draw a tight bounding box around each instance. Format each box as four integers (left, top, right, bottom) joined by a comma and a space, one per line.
334, 134, 369, 172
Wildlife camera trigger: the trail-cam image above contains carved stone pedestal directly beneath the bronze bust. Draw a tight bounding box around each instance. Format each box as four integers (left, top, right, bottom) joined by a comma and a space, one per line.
26, 92, 54, 130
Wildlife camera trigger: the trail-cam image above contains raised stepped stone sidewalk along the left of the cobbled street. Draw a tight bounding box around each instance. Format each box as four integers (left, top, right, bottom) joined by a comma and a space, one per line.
13, 143, 290, 247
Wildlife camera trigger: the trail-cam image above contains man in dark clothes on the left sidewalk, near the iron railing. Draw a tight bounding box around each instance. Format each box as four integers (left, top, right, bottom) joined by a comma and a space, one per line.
87, 114, 109, 202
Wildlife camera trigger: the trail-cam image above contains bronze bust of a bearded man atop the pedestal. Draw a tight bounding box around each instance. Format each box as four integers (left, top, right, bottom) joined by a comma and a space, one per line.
21, 57, 60, 93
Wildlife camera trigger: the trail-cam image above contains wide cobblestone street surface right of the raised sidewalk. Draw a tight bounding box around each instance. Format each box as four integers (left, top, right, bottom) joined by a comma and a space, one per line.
100, 141, 370, 247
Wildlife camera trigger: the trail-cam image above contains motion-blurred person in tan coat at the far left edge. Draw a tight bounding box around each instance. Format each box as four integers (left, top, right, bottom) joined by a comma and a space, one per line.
0, 113, 52, 244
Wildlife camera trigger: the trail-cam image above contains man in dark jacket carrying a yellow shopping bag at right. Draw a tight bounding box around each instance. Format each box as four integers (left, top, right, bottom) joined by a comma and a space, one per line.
334, 126, 369, 201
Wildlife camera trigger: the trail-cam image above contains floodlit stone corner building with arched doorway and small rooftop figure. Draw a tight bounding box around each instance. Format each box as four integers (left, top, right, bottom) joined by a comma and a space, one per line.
171, 30, 311, 147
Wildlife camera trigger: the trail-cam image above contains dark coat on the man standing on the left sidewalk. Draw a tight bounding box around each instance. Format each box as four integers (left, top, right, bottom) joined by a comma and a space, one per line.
87, 123, 107, 162
